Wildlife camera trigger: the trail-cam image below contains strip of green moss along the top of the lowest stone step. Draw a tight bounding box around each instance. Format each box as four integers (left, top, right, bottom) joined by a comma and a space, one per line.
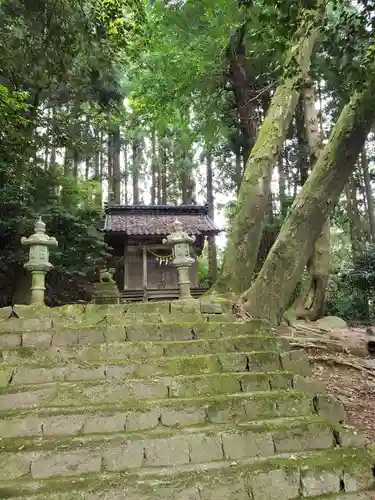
0, 449, 372, 500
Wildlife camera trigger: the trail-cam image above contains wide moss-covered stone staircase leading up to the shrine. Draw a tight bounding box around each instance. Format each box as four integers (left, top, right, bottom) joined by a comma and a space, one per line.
0, 301, 375, 500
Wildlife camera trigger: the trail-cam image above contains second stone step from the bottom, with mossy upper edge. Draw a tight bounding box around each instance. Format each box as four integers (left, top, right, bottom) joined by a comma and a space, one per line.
0, 419, 360, 481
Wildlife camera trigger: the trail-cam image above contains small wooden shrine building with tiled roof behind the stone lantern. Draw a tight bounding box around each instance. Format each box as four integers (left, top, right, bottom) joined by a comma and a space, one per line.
103, 204, 220, 300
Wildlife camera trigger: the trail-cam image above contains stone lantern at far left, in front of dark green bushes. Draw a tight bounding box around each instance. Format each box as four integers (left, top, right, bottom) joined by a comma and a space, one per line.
21, 218, 57, 304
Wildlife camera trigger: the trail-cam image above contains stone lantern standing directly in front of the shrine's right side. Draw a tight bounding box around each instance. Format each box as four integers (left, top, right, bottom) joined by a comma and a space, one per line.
163, 220, 195, 299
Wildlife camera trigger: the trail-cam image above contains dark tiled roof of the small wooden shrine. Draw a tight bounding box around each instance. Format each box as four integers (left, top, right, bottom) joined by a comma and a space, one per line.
104, 205, 220, 236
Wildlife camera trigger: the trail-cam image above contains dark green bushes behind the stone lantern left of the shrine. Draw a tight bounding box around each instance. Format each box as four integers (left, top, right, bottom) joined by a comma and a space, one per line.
0, 147, 108, 305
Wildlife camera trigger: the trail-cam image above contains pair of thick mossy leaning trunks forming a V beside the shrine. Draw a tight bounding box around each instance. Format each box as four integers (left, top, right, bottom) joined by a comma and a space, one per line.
214, 0, 375, 323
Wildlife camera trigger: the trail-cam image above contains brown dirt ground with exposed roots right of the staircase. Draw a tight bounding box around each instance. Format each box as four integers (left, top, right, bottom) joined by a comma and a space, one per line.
284, 323, 375, 443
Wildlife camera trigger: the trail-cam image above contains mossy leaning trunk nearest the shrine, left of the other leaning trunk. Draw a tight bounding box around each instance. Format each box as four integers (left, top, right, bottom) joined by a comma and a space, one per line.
214, 6, 321, 295
